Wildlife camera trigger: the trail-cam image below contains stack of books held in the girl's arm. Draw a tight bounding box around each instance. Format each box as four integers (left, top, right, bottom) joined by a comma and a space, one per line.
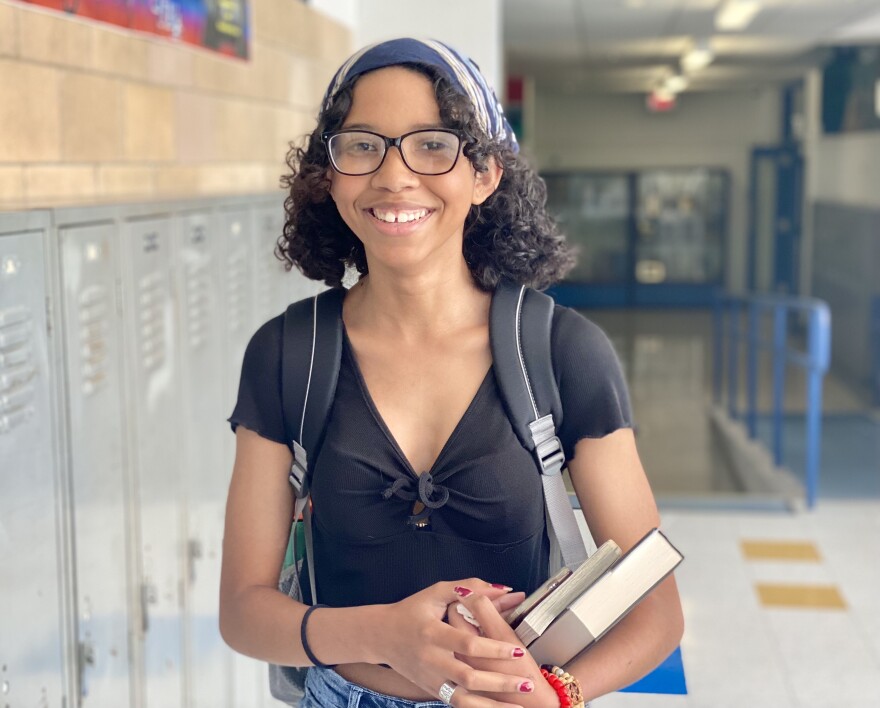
507, 529, 684, 666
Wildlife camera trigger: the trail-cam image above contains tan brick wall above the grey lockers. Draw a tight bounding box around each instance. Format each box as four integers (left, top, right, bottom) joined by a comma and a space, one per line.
0, 0, 352, 209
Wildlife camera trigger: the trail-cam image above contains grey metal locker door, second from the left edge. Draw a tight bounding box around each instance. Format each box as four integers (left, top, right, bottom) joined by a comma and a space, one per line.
58, 224, 131, 708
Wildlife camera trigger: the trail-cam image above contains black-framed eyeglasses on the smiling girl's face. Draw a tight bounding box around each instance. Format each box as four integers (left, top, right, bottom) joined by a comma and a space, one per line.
321, 129, 462, 176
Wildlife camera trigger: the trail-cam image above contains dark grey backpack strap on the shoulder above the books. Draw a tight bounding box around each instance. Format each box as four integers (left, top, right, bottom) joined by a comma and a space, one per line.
489, 280, 587, 570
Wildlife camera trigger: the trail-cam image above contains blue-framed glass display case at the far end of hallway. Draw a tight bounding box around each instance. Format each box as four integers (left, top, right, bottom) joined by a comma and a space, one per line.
544, 168, 728, 307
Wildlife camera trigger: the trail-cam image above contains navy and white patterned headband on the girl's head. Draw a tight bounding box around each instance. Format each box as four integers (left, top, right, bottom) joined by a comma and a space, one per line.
322, 38, 519, 152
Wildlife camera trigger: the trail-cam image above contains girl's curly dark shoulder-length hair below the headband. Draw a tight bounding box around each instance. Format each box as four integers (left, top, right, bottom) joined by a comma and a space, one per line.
275, 63, 574, 291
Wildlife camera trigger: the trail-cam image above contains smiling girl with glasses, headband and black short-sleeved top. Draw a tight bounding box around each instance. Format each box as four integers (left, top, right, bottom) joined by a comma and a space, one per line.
220, 39, 682, 708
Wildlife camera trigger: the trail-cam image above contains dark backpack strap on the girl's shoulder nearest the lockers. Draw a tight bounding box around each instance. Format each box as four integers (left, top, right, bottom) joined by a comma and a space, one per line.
281, 288, 345, 604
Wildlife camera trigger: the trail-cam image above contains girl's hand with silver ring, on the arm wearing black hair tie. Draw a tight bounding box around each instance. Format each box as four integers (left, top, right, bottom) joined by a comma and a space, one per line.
375, 578, 540, 708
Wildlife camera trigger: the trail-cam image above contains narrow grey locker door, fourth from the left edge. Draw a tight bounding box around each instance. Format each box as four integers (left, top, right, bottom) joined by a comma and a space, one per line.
175, 213, 232, 708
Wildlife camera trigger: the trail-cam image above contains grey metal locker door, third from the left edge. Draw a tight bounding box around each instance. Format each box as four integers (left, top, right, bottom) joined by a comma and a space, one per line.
122, 218, 185, 708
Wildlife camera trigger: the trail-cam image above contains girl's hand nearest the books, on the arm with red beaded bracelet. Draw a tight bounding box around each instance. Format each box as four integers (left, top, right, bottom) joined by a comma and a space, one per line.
449, 593, 559, 708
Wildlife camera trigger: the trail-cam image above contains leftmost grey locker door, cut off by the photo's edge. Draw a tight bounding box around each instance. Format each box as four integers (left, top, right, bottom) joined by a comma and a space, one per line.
0, 224, 66, 706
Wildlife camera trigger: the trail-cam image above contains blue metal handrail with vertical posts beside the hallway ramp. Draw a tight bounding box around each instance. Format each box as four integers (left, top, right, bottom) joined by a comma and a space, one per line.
713, 295, 831, 508
